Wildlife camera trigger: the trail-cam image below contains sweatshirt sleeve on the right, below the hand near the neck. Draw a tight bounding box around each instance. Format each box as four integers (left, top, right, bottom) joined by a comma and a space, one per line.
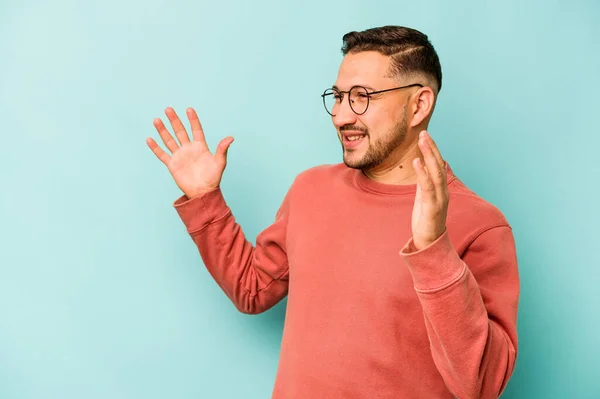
400, 226, 520, 399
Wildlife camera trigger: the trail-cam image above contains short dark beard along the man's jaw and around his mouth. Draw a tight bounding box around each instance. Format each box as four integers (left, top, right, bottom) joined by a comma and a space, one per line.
342, 109, 408, 170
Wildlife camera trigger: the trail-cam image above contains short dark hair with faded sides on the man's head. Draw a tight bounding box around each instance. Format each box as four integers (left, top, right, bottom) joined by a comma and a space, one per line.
342, 25, 442, 93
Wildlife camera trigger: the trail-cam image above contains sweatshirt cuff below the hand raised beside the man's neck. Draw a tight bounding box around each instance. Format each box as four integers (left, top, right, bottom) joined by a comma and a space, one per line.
400, 230, 467, 291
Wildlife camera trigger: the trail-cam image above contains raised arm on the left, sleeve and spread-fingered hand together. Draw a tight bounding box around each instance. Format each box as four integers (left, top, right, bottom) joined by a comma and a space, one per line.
146, 107, 289, 313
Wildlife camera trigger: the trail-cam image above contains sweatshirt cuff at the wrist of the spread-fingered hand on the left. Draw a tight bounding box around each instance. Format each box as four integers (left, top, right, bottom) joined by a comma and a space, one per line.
173, 188, 231, 233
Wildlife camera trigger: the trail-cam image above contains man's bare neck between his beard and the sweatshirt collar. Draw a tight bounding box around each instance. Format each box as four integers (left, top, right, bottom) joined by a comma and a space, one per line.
363, 141, 423, 185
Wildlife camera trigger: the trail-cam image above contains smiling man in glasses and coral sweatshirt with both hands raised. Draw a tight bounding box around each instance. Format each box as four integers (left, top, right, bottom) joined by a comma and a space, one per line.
148, 26, 519, 399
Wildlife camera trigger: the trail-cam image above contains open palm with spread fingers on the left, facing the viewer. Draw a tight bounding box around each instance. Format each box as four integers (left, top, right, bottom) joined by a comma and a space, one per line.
146, 107, 233, 198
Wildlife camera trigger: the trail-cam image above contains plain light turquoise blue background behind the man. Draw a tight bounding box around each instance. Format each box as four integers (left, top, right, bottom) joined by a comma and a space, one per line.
0, 0, 600, 399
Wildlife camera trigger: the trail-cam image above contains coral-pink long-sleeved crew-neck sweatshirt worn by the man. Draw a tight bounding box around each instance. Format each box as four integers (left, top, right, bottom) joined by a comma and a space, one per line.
174, 164, 519, 399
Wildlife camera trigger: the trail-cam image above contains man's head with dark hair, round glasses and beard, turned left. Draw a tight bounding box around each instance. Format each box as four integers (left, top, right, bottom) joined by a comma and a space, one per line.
324, 26, 442, 170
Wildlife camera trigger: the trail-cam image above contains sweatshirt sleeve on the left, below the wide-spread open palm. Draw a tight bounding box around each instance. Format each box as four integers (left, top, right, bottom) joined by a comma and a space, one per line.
174, 188, 289, 314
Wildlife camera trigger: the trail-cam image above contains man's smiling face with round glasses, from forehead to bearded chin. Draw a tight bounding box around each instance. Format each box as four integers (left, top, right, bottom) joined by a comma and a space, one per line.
332, 51, 408, 170
